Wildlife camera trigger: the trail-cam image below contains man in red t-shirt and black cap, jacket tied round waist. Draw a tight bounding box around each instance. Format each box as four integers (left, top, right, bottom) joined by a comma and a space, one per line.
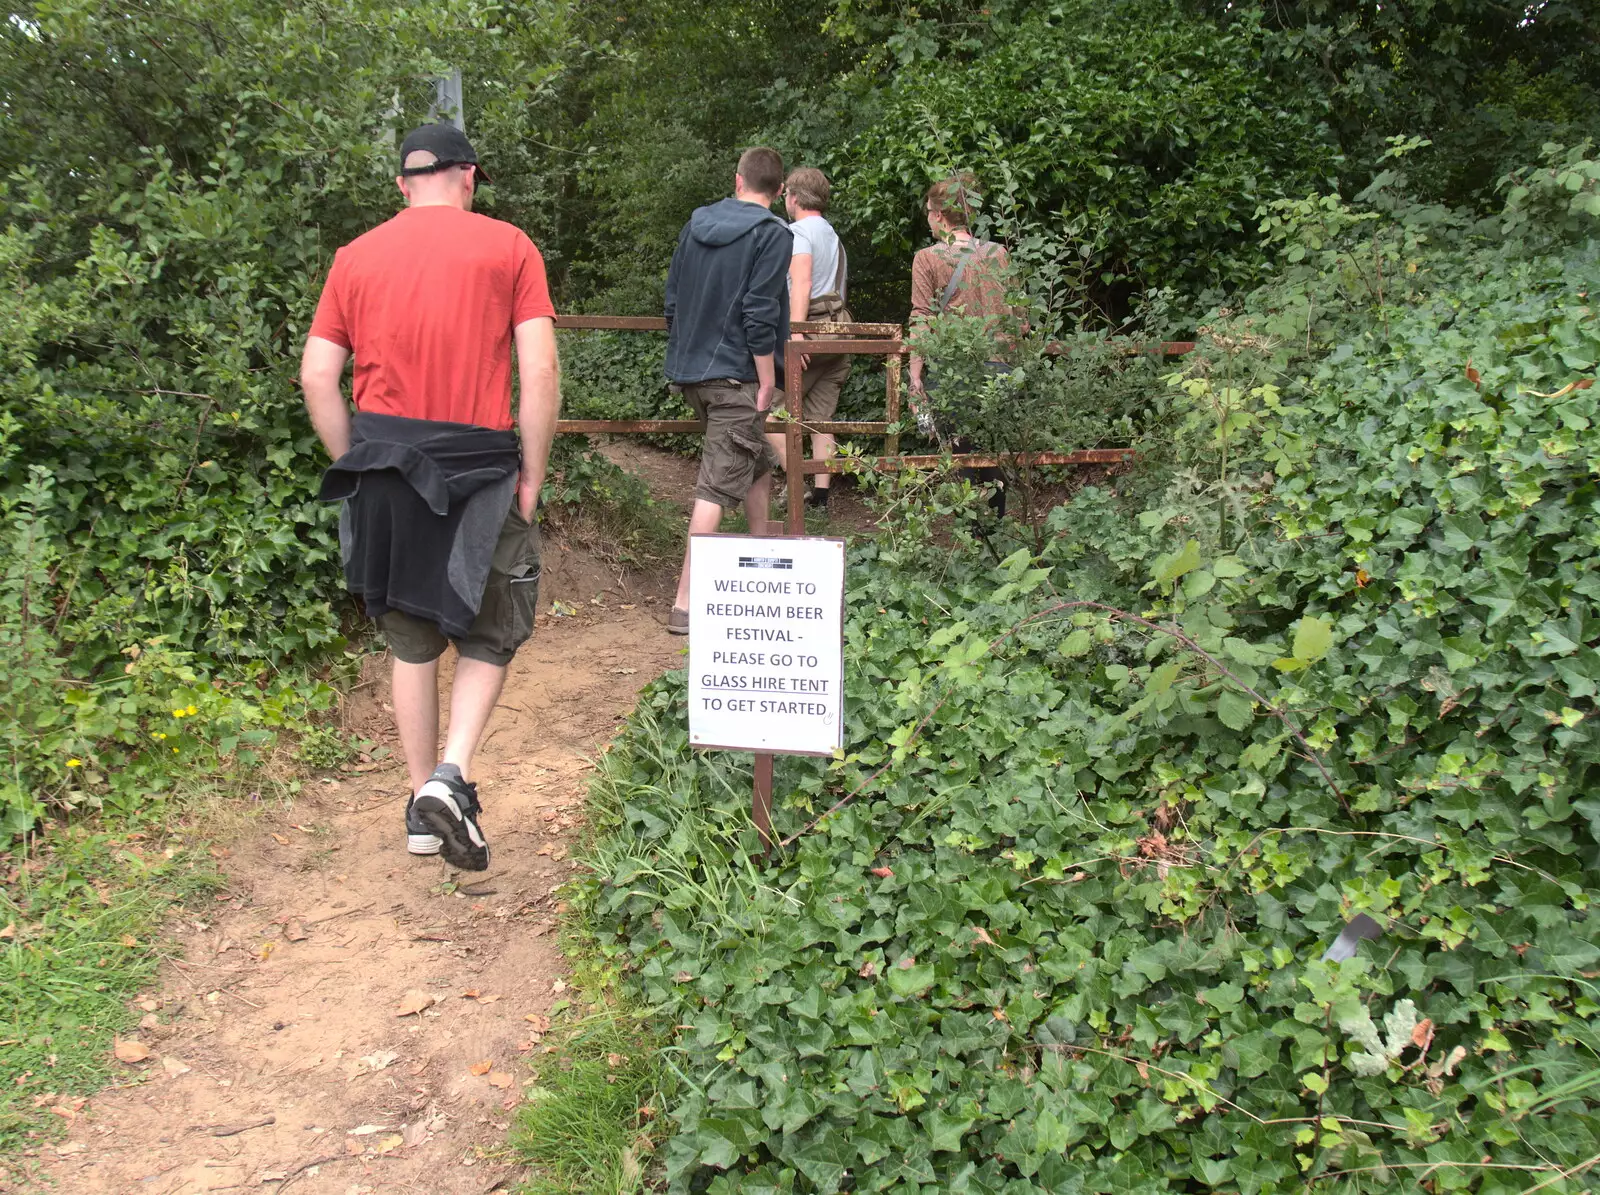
301, 125, 560, 870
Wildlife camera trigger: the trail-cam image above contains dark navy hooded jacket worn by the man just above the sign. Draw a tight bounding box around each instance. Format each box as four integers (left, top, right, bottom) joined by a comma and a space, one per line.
666, 198, 794, 387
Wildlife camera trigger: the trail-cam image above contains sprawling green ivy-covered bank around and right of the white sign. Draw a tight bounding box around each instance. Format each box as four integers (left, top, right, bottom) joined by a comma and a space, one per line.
569, 147, 1600, 1195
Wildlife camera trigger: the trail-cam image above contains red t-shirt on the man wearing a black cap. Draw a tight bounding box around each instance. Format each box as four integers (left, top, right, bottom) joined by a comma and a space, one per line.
310, 206, 555, 430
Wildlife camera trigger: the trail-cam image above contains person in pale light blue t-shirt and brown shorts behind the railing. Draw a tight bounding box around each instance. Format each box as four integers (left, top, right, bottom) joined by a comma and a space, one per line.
768, 166, 850, 510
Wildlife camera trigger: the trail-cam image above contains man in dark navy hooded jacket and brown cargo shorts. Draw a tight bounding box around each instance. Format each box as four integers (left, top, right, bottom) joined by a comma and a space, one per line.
666, 146, 794, 635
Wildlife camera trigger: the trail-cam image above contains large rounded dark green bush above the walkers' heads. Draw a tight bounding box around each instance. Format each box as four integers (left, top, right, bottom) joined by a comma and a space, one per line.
816, 0, 1334, 326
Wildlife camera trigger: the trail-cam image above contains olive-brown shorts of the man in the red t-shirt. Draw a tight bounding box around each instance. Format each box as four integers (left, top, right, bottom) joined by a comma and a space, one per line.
378, 499, 539, 667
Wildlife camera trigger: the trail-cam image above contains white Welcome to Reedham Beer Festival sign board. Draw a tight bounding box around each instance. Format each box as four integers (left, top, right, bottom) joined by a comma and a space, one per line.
690, 536, 845, 755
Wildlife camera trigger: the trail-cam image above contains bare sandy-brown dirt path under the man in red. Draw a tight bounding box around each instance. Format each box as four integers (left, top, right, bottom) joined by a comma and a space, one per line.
38, 549, 683, 1195
